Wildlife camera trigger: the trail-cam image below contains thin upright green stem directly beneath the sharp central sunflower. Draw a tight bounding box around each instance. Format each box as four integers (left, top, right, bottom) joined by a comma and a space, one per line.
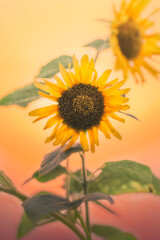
79, 152, 91, 240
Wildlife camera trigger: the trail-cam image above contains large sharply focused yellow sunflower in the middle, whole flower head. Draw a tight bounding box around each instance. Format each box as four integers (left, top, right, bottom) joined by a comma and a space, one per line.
29, 55, 129, 152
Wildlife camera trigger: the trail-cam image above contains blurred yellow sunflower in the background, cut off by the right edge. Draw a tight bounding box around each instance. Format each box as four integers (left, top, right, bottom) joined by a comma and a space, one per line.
110, 0, 160, 82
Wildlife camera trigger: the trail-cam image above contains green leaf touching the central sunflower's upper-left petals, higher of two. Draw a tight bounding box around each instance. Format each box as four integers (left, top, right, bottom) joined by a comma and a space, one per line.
37, 56, 72, 78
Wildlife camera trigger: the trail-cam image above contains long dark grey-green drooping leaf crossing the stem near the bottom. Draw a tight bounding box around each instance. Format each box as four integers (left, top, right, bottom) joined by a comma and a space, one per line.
22, 193, 113, 222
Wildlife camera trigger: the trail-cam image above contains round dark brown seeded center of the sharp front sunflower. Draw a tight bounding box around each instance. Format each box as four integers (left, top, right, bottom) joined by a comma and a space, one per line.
58, 83, 104, 131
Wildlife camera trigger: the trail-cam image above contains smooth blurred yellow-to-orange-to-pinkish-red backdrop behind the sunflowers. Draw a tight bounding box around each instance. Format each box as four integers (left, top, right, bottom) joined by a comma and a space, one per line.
0, 0, 160, 240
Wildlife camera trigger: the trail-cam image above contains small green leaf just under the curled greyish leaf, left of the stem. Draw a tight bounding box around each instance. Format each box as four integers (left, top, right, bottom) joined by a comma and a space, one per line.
24, 165, 68, 184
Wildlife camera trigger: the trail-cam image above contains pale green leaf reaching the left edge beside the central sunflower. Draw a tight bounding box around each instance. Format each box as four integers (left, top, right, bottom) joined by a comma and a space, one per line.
0, 83, 40, 107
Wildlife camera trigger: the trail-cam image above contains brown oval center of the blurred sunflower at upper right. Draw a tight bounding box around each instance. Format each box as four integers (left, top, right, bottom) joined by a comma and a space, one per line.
117, 20, 142, 60
